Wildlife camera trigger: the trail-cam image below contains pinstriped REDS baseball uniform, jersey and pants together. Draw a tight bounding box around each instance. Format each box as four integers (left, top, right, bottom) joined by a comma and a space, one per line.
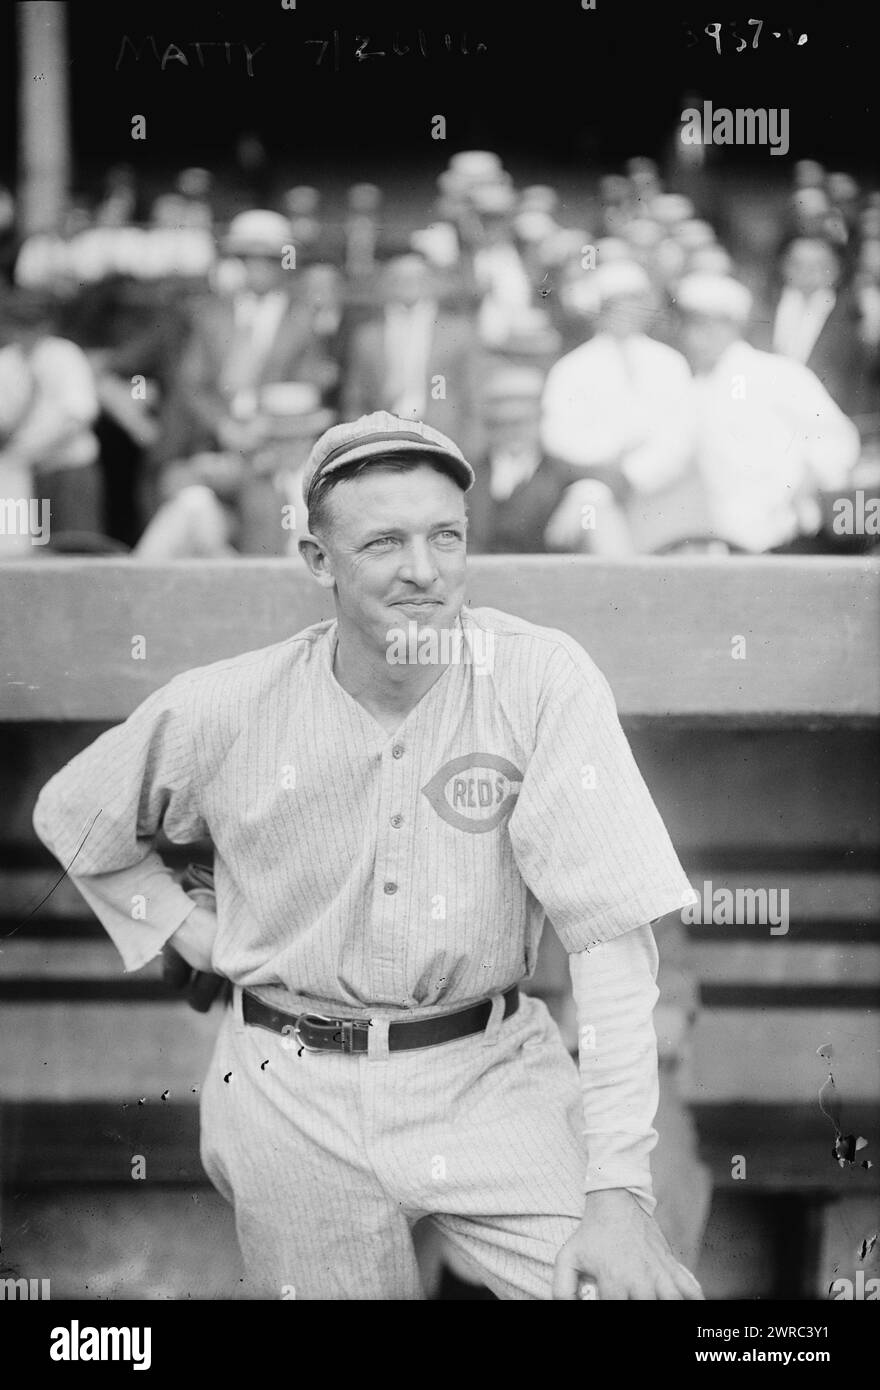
35, 607, 690, 1298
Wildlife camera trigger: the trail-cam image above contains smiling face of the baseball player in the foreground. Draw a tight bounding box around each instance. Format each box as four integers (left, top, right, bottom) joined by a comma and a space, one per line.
314, 464, 467, 651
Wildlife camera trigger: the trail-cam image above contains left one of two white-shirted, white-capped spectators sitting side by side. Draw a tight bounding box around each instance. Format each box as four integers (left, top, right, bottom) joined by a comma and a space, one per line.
542, 260, 695, 550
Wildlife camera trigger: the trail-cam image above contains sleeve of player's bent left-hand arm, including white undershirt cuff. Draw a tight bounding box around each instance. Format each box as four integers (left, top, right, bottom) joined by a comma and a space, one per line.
33, 677, 209, 970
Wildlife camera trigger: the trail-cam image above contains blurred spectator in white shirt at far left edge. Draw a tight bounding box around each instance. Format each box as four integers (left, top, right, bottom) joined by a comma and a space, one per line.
0, 289, 104, 538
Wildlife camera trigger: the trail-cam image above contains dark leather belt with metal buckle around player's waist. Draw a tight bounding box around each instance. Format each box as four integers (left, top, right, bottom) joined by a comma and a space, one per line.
242, 984, 520, 1052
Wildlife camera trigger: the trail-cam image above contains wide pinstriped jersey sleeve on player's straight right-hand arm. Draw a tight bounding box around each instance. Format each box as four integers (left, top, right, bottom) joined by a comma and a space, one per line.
509, 634, 692, 952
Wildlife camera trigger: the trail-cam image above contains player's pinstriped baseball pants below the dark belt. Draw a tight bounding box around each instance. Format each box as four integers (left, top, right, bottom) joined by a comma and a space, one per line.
202, 987, 587, 1300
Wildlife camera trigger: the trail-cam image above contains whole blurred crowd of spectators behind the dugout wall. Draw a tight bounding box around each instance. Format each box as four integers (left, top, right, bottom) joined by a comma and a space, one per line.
0, 150, 880, 560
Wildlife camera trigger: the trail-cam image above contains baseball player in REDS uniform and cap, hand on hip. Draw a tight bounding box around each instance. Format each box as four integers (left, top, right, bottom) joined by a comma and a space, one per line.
35, 411, 702, 1300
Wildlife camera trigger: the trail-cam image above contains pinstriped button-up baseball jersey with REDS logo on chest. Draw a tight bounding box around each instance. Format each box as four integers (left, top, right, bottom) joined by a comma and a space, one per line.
33, 607, 690, 1017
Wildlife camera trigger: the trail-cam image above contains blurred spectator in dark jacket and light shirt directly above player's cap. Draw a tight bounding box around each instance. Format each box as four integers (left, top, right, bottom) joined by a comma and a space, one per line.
342, 252, 478, 453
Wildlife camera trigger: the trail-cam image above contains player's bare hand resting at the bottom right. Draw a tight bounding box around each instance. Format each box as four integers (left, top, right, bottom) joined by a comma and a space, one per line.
553, 1188, 703, 1301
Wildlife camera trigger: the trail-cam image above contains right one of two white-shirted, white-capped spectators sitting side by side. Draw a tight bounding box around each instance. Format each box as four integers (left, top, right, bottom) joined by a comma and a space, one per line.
678, 274, 859, 552
